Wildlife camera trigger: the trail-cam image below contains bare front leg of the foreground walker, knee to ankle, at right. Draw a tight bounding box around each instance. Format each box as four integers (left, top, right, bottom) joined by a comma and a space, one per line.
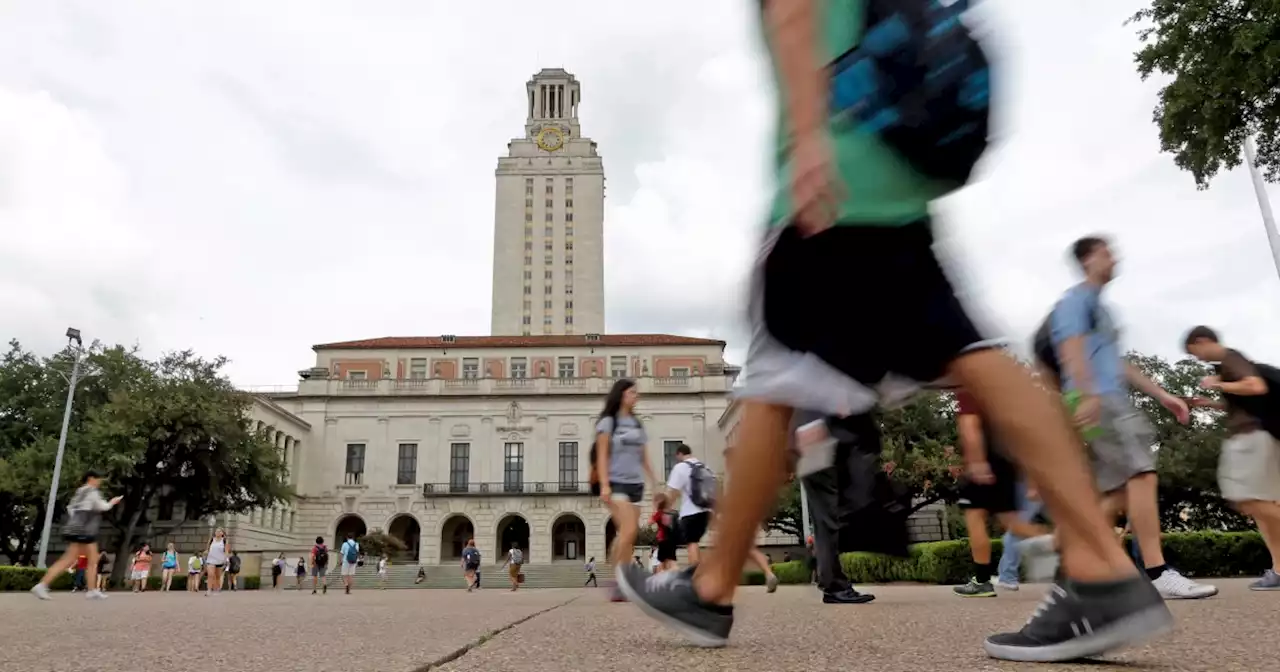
947, 351, 1135, 581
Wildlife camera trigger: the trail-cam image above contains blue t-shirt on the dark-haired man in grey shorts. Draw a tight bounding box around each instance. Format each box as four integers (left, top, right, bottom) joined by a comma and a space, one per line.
1050, 283, 1129, 397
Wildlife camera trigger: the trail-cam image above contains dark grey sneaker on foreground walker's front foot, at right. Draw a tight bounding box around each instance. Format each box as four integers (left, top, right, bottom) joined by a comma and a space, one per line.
983, 576, 1174, 663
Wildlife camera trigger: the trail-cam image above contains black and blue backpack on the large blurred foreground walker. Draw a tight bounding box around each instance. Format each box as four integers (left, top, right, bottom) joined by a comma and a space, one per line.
829, 0, 991, 187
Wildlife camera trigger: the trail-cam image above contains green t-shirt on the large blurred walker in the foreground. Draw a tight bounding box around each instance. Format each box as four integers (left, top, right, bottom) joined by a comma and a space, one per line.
765, 0, 951, 227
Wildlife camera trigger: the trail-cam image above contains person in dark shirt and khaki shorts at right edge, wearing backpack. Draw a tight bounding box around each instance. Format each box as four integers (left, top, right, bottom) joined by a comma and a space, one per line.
1185, 326, 1280, 590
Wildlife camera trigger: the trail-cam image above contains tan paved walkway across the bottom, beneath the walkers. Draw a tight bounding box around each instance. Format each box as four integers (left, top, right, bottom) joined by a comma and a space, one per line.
0, 580, 1280, 672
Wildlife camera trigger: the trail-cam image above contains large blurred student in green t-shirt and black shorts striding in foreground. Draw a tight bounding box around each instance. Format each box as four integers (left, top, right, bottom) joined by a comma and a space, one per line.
618, 0, 1172, 662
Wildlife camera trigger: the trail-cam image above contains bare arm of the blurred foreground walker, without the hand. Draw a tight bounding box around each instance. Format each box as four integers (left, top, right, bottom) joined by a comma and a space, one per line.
764, 0, 827, 137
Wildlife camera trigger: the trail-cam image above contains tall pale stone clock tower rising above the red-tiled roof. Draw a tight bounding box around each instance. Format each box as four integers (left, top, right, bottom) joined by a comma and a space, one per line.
492, 68, 604, 335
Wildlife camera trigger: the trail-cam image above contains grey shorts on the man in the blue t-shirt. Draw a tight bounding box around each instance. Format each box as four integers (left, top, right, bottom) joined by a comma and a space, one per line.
1089, 396, 1156, 494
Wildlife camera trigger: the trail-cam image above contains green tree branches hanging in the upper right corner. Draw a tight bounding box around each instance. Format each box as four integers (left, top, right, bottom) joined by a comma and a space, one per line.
1130, 0, 1280, 188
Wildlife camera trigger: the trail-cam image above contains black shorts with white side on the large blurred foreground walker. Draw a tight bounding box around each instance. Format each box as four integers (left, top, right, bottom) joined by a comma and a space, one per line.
742, 219, 995, 413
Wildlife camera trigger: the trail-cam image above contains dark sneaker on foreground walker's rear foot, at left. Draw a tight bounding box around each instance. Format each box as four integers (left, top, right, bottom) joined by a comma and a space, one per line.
616, 566, 733, 648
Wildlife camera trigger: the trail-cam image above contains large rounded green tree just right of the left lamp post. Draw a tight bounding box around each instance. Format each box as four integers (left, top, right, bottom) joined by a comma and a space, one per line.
82, 348, 292, 580
